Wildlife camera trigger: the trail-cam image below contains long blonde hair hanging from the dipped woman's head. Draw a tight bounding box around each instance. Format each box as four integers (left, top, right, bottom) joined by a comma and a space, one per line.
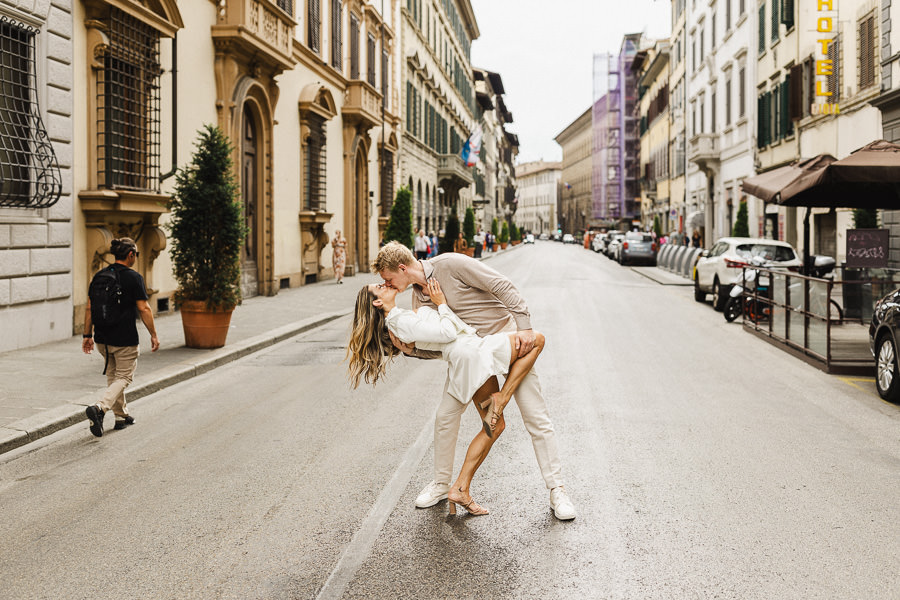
347, 286, 400, 389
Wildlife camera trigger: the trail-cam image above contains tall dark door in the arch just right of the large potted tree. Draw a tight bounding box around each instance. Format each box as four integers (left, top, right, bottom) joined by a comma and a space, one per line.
241, 104, 259, 298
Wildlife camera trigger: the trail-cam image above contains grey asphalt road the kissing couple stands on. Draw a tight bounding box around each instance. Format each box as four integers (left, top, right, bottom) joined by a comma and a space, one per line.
0, 242, 900, 600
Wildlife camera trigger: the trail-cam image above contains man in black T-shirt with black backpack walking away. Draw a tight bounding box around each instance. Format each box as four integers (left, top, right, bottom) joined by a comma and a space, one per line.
81, 238, 159, 437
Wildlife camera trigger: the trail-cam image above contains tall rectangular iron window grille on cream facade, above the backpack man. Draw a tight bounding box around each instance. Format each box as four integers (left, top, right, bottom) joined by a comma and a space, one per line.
97, 7, 162, 191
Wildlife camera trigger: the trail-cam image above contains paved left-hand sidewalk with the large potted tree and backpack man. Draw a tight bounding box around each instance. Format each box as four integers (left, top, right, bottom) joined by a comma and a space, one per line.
0, 246, 513, 454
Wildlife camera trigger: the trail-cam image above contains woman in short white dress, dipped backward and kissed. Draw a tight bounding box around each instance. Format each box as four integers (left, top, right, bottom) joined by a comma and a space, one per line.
347, 279, 544, 515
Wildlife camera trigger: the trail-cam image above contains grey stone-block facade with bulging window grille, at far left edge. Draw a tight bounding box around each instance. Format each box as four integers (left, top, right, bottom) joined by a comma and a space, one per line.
0, 0, 75, 352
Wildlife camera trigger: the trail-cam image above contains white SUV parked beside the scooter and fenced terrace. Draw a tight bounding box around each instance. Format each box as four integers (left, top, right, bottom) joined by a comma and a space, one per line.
694, 237, 803, 310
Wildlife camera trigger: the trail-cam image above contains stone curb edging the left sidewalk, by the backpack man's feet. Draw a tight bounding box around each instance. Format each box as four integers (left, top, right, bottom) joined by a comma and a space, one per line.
0, 310, 353, 454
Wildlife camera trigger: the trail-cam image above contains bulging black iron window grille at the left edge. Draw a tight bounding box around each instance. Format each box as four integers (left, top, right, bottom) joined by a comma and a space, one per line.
0, 17, 62, 208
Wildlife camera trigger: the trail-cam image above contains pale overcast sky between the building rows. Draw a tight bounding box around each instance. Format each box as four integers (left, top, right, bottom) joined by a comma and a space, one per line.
470, 0, 671, 162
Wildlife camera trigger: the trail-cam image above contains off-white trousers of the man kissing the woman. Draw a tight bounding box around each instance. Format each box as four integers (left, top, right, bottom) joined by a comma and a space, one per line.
434, 328, 563, 490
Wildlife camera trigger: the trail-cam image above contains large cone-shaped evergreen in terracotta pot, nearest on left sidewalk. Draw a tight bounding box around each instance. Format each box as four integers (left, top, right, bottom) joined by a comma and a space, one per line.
167, 125, 247, 348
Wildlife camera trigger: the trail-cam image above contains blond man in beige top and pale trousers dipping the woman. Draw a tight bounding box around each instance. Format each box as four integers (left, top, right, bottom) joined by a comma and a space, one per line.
372, 242, 575, 521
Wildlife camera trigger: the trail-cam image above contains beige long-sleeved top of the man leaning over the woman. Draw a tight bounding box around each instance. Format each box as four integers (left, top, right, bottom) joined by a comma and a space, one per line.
412, 252, 531, 337
